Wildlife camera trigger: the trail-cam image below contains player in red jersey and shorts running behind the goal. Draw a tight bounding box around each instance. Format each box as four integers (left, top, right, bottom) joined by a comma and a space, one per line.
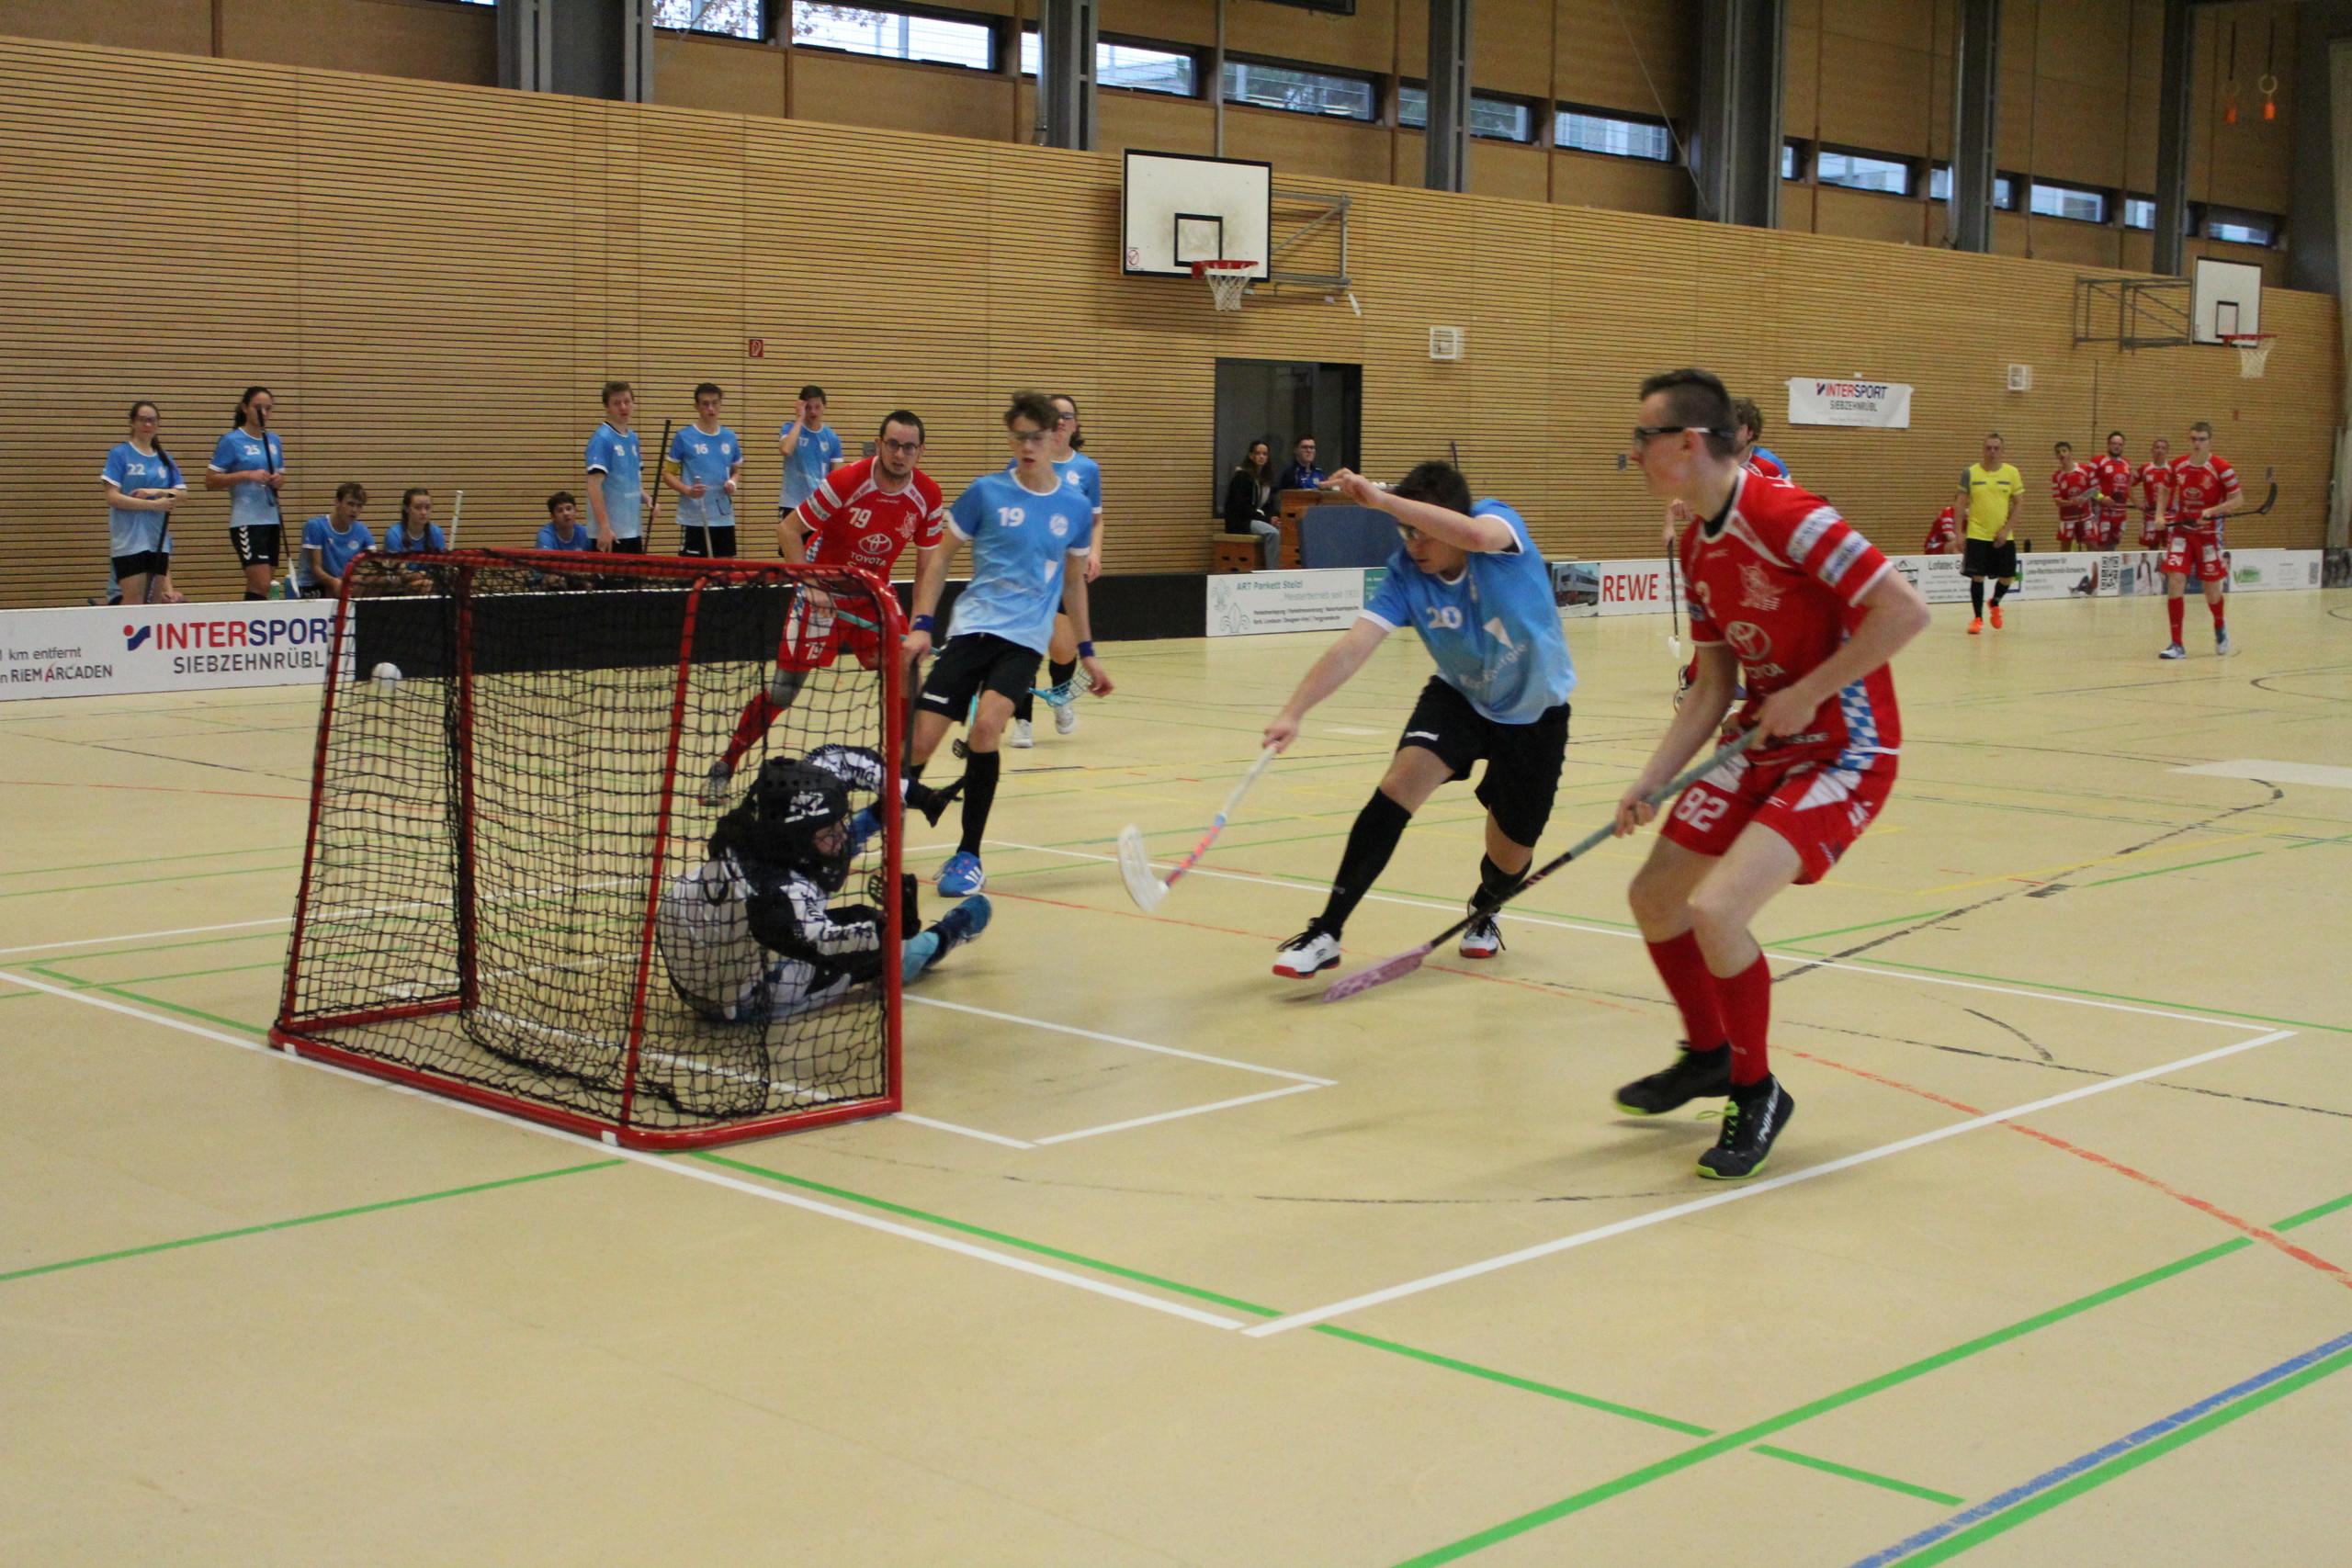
703, 409, 948, 820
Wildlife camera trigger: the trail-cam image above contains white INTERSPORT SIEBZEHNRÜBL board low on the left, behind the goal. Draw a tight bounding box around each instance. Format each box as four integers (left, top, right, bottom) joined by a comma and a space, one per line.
0, 600, 334, 698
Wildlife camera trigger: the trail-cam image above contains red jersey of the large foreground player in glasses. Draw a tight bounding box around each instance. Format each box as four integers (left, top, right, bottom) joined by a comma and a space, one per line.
1681, 472, 1903, 769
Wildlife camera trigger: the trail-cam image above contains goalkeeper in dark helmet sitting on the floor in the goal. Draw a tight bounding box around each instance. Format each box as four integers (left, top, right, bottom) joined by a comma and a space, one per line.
656, 745, 988, 1022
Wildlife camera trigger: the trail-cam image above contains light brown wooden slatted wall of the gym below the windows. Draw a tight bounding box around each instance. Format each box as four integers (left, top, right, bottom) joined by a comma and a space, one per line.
0, 40, 2340, 604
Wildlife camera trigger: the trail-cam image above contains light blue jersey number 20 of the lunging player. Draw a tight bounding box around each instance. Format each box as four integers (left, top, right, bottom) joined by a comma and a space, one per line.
1362, 501, 1576, 724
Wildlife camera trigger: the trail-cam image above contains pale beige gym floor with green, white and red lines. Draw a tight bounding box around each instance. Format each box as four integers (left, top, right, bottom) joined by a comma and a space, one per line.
0, 592, 2352, 1568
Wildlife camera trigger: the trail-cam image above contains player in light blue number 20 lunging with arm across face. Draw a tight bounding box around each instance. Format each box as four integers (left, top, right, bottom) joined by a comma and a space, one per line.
1265, 463, 1576, 980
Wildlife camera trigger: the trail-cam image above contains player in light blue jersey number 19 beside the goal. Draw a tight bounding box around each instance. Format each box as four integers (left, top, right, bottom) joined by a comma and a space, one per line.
906, 392, 1110, 898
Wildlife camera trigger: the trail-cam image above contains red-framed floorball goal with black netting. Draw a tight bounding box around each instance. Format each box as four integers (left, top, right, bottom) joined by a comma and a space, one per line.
273, 550, 912, 1147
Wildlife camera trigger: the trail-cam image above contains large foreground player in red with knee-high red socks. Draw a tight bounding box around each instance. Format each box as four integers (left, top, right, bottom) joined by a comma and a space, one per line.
1616, 369, 1928, 1180
